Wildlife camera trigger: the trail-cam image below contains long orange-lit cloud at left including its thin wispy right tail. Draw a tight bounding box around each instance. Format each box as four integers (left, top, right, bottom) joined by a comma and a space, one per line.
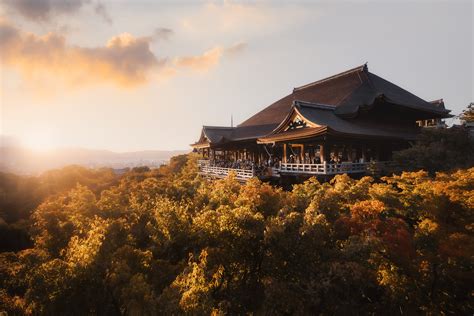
0, 20, 247, 91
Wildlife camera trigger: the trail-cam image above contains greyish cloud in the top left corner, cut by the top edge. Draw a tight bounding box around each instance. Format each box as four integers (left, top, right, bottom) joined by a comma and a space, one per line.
0, 0, 112, 23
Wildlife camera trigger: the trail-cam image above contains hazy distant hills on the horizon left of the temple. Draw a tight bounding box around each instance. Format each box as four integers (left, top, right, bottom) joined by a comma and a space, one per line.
0, 146, 189, 175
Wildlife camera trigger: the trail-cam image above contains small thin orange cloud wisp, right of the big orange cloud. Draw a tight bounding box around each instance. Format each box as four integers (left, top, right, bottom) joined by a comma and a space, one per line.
174, 42, 247, 71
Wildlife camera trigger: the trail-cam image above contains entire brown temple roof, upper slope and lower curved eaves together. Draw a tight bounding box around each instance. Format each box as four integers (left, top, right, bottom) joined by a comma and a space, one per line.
194, 64, 450, 145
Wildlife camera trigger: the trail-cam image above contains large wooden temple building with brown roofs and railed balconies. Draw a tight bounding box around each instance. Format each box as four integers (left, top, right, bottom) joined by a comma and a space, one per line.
191, 64, 451, 180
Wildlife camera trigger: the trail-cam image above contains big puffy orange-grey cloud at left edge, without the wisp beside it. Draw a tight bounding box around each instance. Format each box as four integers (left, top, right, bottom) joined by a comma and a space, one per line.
0, 21, 166, 86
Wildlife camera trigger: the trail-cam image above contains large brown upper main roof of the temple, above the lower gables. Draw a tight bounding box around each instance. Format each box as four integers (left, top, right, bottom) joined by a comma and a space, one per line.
239, 64, 450, 127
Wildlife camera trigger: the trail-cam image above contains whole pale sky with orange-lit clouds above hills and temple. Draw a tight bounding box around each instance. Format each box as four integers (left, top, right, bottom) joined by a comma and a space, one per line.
0, 0, 474, 151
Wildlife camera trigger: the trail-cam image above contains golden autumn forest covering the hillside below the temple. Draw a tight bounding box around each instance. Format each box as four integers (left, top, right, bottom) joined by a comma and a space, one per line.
0, 156, 474, 315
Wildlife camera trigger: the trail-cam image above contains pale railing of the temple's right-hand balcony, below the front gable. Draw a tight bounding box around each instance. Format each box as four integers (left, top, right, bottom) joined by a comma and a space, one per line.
280, 162, 370, 175
